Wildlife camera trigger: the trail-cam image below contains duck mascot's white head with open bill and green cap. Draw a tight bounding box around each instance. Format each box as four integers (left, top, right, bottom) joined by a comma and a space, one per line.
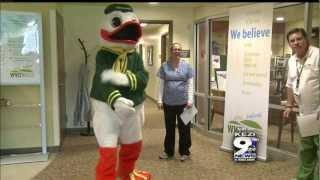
100, 4, 142, 49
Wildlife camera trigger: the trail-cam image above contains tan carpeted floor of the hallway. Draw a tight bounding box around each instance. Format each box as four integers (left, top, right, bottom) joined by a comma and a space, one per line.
3, 99, 298, 180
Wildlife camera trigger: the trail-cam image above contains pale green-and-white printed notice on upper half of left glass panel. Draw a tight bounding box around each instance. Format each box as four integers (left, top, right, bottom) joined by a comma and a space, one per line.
0, 11, 43, 85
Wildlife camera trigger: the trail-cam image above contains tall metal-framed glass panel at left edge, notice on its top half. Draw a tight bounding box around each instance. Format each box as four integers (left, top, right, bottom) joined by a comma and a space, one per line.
0, 11, 47, 164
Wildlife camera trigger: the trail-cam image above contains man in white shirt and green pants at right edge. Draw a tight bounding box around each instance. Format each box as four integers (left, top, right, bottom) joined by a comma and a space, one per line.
283, 28, 320, 180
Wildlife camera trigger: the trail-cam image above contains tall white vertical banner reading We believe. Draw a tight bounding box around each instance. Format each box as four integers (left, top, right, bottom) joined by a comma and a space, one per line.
221, 3, 273, 160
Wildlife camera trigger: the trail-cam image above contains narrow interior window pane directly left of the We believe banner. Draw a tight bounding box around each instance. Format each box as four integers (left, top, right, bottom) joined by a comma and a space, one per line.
208, 17, 229, 133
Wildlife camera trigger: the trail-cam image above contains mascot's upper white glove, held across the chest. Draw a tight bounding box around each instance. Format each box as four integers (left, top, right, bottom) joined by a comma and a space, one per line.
101, 70, 129, 86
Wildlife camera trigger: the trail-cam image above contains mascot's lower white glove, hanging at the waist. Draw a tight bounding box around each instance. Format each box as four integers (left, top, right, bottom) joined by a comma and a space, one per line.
113, 97, 136, 125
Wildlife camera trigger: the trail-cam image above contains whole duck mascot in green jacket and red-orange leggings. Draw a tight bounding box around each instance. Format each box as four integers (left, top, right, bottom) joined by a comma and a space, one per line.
90, 4, 151, 180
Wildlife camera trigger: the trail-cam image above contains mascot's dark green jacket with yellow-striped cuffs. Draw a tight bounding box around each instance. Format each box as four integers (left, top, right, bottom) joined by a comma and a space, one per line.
90, 48, 149, 109
